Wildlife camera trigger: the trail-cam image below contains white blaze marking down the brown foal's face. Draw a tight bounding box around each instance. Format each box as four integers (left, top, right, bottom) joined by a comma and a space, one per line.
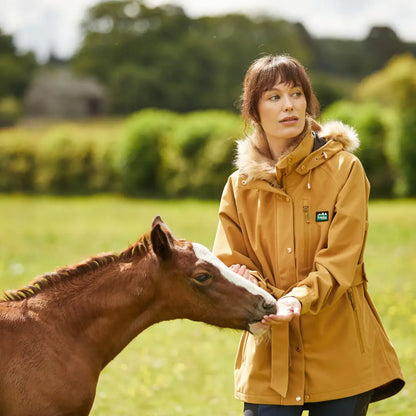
192, 243, 276, 302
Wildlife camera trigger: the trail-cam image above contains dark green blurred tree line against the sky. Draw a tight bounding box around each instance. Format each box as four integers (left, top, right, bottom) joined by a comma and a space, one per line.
0, 0, 416, 118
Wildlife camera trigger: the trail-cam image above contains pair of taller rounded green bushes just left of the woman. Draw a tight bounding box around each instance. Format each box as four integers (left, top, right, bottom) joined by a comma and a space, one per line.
118, 110, 242, 198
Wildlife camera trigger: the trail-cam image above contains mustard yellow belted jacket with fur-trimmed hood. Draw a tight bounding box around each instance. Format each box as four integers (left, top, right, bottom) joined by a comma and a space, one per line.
214, 122, 404, 405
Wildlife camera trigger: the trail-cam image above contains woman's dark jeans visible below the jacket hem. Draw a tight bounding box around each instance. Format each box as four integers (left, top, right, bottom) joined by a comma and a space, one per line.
244, 391, 373, 416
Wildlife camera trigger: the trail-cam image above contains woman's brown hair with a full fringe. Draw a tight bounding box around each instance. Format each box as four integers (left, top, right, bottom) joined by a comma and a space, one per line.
241, 55, 320, 123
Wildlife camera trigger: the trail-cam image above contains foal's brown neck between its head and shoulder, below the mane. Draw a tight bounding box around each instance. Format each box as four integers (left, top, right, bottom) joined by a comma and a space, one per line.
33, 244, 160, 370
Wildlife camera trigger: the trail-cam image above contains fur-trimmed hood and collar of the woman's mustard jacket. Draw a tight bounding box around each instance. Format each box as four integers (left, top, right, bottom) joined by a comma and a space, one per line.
235, 120, 360, 187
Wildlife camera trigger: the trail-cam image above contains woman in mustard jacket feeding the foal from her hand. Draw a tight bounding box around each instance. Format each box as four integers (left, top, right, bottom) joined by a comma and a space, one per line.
214, 56, 404, 416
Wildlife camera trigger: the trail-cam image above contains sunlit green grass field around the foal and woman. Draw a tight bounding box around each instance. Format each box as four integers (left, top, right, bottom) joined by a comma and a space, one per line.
0, 195, 416, 416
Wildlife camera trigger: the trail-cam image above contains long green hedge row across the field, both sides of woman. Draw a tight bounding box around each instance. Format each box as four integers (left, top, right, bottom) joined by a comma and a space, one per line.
0, 106, 416, 198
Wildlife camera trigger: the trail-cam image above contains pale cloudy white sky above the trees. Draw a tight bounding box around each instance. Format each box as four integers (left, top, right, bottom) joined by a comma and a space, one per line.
0, 0, 416, 61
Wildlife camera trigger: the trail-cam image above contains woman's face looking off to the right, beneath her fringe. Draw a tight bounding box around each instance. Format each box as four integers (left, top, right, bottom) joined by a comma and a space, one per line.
258, 82, 307, 141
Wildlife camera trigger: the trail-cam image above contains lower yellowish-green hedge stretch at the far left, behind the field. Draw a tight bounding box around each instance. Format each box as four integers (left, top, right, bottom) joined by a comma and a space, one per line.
0, 118, 118, 194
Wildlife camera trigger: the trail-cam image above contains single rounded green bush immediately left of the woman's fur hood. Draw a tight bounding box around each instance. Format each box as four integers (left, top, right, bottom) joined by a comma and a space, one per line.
159, 110, 242, 198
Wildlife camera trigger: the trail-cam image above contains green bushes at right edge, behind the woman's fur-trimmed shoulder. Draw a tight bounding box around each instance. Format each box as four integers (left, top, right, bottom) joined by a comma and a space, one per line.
323, 101, 416, 198
